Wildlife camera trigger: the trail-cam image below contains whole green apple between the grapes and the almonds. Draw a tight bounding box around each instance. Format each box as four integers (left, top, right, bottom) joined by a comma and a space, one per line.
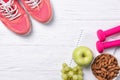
72, 46, 93, 66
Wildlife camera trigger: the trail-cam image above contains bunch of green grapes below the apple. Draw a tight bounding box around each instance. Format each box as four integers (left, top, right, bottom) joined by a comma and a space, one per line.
61, 63, 83, 80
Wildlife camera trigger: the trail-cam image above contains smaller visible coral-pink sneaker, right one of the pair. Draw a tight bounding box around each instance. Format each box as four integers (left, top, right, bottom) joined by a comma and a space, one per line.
21, 0, 52, 23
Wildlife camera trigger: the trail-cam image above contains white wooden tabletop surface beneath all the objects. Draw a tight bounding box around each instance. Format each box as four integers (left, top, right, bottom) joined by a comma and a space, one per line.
0, 0, 120, 80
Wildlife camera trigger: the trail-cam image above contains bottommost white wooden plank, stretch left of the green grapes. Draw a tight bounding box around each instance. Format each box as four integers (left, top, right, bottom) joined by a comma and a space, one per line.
0, 70, 60, 80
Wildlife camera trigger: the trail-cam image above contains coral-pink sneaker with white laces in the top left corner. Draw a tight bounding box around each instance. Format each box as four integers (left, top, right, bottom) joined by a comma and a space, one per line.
0, 0, 30, 34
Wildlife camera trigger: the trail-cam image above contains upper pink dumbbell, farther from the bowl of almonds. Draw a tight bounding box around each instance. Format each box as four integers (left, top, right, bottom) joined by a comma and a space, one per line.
97, 26, 120, 41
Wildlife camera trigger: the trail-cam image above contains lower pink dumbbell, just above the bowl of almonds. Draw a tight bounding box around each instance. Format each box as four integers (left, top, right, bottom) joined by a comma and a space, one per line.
96, 40, 120, 53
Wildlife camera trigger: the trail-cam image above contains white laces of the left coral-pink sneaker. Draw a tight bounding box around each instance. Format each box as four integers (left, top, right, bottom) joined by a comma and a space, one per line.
0, 0, 21, 20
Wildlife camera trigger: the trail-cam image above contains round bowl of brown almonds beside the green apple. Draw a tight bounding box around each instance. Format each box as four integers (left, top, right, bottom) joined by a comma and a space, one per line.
91, 54, 120, 80
